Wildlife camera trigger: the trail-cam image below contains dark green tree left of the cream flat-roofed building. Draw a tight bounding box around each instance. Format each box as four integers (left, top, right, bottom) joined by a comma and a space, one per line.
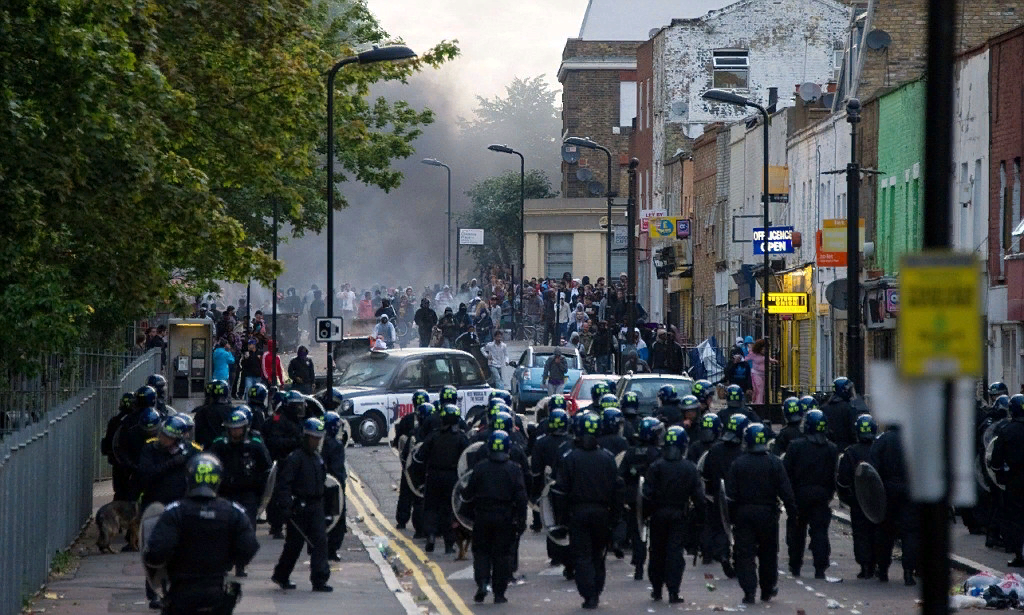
460, 170, 558, 274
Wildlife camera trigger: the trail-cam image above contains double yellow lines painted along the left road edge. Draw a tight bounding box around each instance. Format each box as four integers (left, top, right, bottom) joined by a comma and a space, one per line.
347, 470, 473, 615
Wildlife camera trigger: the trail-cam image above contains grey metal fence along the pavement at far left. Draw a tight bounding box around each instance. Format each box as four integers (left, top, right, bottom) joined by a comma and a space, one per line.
0, 350, 160, 613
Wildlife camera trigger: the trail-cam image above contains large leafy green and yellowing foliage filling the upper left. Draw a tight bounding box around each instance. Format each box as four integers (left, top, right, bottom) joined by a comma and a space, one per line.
0, 0, 458, 370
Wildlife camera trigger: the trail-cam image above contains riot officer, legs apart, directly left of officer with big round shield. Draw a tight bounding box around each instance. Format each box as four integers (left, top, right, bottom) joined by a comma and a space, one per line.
782, 410, 839, 579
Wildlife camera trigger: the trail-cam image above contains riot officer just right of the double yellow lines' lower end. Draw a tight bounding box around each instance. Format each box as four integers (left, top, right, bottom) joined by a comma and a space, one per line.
462, 429, 526, 604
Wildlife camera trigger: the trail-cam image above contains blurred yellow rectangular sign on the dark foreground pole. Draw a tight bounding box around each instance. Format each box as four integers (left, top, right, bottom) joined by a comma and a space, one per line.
898, 252, 982, 379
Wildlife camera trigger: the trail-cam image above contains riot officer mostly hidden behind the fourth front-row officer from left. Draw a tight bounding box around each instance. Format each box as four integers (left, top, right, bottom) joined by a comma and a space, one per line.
700, 412, 750, 578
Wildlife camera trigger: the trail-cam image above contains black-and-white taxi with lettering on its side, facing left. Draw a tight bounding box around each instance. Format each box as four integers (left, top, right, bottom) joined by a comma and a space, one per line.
321, 348, 494, 446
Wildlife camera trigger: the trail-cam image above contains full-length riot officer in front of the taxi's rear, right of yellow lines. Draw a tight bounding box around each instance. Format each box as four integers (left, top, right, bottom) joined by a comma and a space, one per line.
416, 403, 469, 554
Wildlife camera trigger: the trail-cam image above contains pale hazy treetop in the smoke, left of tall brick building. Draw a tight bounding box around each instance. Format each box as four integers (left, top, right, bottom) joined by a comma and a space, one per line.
459, 75, 562, 169
